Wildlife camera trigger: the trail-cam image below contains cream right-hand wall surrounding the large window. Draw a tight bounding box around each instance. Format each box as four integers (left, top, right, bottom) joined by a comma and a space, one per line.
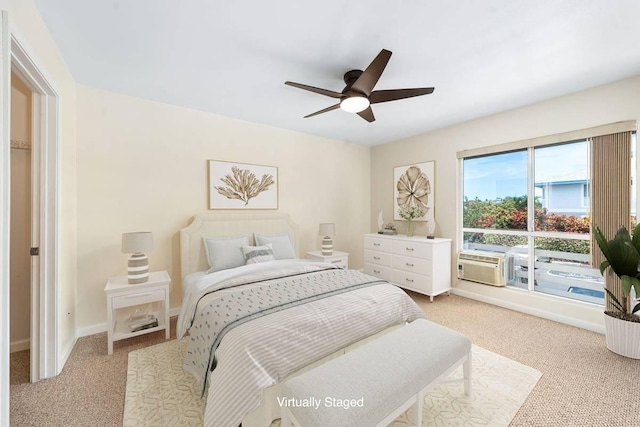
370, 77, 640, 330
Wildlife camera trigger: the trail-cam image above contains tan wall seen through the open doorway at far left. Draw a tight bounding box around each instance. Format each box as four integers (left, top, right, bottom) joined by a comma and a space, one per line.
9, 73, 31, 351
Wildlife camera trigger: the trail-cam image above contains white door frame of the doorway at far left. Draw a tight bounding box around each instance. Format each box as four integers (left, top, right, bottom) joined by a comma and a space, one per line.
0, 11, 64, 425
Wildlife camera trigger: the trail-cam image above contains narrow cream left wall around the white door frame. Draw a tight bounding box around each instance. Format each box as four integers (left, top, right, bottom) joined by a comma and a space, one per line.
0, 0, 77, 369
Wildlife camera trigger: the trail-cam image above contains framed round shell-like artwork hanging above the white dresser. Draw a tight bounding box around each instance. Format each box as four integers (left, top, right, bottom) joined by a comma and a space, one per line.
393, 161, 436, 224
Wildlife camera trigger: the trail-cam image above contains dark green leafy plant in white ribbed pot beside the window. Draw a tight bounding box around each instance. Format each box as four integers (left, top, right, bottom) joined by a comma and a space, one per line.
594, 224, 640, 359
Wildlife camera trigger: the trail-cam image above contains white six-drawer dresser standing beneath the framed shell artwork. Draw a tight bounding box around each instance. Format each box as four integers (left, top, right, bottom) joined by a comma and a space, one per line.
364, 233, 451, 302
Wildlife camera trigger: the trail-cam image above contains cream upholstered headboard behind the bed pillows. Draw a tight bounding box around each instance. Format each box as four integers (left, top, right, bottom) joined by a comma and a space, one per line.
180, 211, 298, 278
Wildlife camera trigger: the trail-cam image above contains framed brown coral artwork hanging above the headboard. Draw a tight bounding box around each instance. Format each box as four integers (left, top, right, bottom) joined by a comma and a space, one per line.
209, 160, 278, 209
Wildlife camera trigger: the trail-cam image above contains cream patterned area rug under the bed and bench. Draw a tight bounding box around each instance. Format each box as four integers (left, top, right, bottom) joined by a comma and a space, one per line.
123, 338, 541, 427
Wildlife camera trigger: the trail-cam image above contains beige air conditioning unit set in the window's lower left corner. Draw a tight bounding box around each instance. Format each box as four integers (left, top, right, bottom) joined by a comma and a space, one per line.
458, 251, 506, 286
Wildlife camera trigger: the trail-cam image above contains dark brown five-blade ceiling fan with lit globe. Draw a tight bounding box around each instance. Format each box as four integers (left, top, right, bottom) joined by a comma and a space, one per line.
284, 49, 433, 123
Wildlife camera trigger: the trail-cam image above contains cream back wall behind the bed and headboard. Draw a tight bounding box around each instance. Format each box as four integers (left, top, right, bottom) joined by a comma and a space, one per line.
77, 85, 370, 334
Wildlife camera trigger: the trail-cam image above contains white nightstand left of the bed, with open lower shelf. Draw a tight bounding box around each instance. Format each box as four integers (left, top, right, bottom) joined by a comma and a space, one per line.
104, 271, 171, 354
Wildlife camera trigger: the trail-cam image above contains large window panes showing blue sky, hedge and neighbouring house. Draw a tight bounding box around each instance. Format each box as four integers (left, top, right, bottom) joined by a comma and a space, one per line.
462, 140, 604, 305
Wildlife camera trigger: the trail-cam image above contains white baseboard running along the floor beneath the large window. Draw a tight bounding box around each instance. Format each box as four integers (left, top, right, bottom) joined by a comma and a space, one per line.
451, 282, 604, 334
